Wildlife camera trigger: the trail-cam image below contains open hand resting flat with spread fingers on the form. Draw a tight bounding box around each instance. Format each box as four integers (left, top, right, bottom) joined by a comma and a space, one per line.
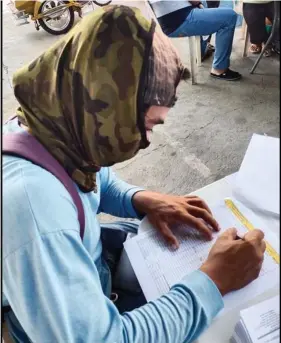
133, 191, 219, 248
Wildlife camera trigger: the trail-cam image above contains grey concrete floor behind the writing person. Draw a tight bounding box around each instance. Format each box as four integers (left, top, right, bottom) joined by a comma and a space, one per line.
3, 2, 280, 199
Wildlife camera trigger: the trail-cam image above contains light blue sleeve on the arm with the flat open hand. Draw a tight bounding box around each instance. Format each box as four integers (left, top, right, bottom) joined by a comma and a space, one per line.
99, 168, 144, 219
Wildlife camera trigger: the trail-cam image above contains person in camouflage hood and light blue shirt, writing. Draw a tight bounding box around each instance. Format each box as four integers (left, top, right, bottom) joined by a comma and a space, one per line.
2, 6, 265, 343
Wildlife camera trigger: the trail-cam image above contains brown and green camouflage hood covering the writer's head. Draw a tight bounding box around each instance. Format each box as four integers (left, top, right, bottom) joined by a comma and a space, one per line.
13, 6, 186, 192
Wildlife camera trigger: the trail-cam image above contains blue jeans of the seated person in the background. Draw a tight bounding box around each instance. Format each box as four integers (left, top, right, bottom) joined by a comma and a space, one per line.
169, 8, 237, 69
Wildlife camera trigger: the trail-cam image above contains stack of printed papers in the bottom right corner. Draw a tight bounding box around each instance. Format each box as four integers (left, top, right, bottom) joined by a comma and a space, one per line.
231, 296, 280, 343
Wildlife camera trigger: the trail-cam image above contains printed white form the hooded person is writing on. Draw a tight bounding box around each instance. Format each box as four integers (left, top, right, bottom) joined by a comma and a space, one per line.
124, 201, 279, 318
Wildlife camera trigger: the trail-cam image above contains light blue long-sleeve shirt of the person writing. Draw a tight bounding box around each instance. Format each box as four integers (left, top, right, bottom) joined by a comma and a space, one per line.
2, 120, 223, 343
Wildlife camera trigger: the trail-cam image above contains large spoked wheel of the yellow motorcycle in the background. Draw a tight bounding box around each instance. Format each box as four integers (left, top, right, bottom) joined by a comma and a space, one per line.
38, 0, 74, 36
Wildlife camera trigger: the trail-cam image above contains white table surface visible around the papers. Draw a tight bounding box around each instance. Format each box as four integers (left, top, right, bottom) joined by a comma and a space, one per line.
185, 174, 280, 343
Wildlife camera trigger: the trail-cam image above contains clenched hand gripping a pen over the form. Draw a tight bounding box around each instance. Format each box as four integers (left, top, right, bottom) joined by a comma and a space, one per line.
200, 228, 266, 296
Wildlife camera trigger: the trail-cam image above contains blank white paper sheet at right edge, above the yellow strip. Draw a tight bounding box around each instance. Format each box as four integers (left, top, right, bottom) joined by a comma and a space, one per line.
233, 134, 280, 215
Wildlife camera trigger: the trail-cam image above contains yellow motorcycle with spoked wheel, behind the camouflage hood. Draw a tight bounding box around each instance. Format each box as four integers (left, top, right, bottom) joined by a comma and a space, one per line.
8, 0, 112, 35
